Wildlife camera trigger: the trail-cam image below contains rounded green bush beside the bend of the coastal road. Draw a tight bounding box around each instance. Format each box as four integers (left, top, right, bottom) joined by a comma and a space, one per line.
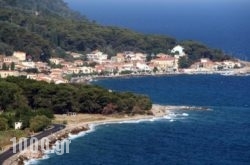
30, 115, 51, 132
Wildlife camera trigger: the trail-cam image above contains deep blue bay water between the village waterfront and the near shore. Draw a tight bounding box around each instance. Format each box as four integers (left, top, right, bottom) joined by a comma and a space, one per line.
33, 75, 250, 165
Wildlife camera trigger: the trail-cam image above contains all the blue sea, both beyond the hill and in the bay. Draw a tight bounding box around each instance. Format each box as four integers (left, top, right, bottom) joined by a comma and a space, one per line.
29, 0, 250, 165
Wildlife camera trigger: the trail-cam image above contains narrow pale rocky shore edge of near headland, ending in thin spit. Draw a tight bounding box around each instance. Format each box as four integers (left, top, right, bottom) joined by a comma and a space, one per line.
4, 104, 211, 165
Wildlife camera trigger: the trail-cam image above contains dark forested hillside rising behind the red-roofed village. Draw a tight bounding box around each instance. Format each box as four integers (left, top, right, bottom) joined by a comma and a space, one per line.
0, 0, 231, 62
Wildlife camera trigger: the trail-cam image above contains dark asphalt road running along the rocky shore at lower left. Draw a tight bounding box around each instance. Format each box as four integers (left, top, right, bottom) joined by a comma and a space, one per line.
0, 124, 65, 165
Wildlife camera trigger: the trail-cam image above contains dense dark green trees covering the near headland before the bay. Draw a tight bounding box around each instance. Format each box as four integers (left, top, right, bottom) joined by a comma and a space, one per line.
0, 77, 152, 130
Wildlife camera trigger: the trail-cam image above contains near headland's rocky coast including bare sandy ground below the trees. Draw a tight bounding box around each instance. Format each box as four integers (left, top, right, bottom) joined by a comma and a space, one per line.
3, 104, 211, 165
